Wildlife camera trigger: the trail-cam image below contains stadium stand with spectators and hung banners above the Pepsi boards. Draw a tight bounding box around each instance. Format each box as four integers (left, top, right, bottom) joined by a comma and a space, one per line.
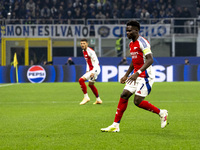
0, 0, 200, 82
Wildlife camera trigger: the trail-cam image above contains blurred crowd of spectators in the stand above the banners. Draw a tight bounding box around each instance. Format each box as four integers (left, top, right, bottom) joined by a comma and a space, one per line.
0, 0, 197, 24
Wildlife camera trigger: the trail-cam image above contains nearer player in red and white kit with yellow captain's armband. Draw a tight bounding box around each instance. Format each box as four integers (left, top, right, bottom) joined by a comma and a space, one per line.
101, 20, 168, 132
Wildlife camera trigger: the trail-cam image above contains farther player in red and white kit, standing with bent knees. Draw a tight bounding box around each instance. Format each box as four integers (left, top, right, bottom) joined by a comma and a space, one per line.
79, 39, 102, 105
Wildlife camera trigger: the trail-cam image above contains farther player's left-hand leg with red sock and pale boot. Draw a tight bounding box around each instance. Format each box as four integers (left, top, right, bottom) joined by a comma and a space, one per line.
79, 73, 90, 105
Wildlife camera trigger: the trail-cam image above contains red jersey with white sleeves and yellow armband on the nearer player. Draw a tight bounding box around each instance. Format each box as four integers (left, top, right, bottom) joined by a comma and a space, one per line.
129, 36, 155, 78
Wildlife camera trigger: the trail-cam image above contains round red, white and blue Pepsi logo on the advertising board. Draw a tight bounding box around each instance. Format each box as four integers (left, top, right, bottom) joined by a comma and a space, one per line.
27, 66, 46, 83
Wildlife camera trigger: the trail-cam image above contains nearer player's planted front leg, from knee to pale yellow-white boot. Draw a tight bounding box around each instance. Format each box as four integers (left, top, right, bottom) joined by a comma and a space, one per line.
101, 89, 132, 132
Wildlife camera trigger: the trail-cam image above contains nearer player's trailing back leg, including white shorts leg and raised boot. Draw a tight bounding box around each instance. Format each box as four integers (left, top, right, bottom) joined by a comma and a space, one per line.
134, 79, 168, 128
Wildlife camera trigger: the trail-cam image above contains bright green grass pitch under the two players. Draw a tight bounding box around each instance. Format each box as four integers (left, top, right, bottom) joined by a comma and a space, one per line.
0, 82, 200, 150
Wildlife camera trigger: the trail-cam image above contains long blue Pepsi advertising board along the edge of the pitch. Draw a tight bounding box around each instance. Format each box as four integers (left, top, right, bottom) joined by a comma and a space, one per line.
0, 65, 200, 83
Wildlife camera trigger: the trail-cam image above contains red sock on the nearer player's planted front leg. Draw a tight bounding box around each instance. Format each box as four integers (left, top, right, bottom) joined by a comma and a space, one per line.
114, 98, 128, 123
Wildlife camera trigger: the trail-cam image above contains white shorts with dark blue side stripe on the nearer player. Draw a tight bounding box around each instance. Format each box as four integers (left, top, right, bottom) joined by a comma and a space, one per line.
124, 77, 154, 97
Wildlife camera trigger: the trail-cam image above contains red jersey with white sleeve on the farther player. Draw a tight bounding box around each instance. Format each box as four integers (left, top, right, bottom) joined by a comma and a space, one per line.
83, 47, 100, 71
